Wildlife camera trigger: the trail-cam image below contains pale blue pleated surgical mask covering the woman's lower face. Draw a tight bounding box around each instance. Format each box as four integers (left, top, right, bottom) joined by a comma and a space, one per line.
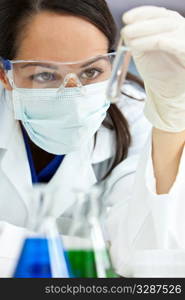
12, 81, 110, 155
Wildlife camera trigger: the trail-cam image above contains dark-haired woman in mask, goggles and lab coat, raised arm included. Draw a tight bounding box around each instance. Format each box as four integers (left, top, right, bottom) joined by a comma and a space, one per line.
0, 0, 184, 276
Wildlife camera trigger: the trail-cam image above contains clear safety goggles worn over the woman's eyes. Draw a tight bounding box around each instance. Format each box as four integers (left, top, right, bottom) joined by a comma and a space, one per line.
0, 48, 130, 89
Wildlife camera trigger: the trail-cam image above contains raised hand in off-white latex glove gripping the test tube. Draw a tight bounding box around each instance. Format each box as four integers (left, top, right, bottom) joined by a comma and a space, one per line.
122, 6, 185, 132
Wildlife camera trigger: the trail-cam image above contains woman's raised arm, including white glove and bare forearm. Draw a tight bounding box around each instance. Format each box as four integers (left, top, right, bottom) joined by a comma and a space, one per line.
122, 6, 185, 194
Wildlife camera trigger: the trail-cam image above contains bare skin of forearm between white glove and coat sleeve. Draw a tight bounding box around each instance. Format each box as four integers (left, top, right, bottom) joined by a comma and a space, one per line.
152, 128, 185, 194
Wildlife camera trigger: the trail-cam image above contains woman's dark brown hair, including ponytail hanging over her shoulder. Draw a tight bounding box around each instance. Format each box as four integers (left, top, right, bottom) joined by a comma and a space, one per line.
0, 0, 131, 178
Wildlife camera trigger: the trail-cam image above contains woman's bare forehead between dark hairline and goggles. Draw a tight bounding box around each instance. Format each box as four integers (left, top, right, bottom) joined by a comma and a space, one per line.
16, 12, 108, 62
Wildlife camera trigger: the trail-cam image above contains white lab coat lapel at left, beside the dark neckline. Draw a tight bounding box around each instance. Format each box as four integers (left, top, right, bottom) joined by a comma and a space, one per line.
0, 86, 31, 210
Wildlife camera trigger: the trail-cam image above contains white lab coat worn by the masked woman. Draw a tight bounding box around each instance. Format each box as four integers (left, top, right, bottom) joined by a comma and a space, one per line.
0, 79, 183, 277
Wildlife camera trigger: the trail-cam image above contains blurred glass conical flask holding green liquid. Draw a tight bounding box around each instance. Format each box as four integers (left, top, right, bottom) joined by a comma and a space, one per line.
65, 188, 117, 278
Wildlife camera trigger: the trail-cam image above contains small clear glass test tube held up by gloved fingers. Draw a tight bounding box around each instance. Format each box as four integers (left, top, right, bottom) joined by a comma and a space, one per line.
106, 38, 131, 103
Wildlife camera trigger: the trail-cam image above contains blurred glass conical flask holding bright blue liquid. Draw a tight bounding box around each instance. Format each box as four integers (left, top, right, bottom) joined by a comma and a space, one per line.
13, 185, 70, 278
